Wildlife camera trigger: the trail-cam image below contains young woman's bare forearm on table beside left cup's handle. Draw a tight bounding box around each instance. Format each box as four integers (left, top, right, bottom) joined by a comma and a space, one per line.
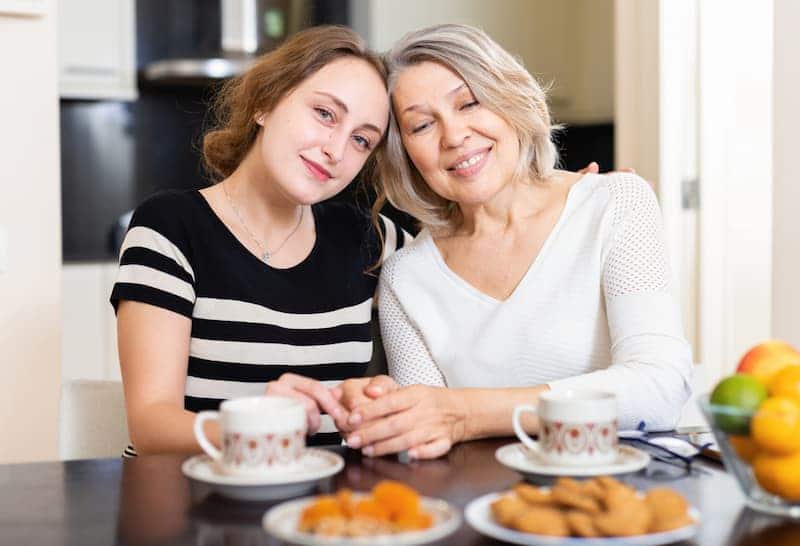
128, 403, 220, 455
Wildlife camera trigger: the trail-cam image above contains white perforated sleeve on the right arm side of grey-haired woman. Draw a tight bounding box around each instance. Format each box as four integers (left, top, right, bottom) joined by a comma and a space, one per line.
550, 175, 694, 430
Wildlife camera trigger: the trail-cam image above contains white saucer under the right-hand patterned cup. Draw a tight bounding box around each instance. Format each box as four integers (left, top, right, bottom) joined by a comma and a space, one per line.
494, 442, 650, 478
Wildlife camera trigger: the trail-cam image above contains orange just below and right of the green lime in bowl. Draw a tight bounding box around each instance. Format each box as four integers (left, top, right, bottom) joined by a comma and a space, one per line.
750, 396, 800, 455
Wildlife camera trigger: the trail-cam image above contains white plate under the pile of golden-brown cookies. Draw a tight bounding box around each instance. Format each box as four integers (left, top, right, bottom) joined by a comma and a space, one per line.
464, 493, 700, 546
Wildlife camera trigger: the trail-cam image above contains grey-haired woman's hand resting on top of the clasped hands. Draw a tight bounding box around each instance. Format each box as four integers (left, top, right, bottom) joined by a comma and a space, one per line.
347, 385, 466, 459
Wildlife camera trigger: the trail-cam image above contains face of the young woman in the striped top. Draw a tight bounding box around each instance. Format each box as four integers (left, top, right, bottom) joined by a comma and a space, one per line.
257, 57, 389, 204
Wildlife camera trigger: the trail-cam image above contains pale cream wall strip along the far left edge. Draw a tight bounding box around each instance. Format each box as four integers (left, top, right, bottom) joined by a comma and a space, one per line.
0, 0, 61, 463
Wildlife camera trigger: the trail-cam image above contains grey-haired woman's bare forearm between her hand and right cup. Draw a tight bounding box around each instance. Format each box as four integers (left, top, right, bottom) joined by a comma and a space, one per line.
451, 385, 549, 441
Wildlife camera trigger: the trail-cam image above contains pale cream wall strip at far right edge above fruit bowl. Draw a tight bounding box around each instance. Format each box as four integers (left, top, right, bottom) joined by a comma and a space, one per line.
772, 0, 800, 347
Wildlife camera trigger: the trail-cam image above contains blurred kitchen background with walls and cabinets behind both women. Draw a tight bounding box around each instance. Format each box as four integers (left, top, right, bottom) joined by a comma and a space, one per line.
0, 0, 800, 462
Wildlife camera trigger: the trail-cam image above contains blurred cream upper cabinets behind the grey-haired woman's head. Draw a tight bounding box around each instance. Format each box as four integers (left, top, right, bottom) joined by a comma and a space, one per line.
351, 0, 614, 123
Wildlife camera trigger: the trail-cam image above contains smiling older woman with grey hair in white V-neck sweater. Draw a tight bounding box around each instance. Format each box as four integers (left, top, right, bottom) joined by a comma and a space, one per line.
344, 25, 692, 458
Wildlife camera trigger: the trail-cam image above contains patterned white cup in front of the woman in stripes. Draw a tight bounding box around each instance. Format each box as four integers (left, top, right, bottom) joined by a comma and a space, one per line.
194, 396, 306, 476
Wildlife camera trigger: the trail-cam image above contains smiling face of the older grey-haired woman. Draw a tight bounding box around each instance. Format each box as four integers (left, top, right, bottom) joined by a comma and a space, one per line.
392, 62, 519, 206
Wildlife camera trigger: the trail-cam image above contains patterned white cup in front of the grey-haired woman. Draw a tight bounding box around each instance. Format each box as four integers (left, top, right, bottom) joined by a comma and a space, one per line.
513, 390, 618, 466
